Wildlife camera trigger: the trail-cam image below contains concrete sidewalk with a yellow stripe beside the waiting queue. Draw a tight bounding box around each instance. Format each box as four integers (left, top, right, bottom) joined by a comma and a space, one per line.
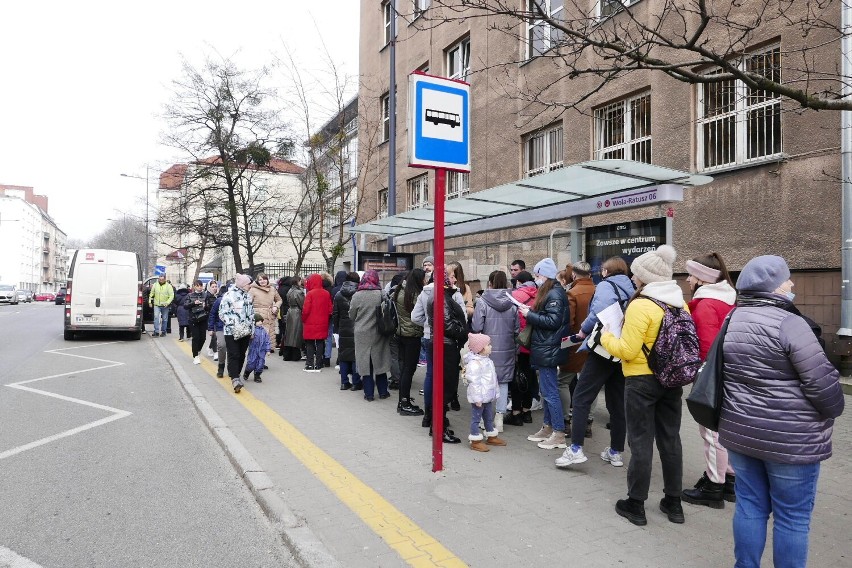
155, 337, 852, 568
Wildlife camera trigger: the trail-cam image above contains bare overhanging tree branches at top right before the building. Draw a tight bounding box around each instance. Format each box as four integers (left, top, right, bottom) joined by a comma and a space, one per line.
432, 0, 852, 111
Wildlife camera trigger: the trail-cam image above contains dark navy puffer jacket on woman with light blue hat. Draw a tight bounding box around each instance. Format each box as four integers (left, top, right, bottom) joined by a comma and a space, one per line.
527, 282, 571, 367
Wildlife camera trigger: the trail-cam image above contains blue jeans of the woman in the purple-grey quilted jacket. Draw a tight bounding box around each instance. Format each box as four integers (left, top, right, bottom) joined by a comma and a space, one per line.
728, 449, 820, 568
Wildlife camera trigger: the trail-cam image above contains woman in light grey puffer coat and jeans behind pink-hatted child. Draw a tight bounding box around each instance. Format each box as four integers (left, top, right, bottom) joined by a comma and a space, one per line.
470, 270, 520, 432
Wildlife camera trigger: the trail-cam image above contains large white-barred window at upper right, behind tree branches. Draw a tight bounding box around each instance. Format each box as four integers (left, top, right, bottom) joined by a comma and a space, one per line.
698, 47, 781, 170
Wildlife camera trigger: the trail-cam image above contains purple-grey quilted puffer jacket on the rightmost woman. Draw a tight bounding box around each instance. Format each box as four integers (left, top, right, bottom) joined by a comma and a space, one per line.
719, 296, 844, 464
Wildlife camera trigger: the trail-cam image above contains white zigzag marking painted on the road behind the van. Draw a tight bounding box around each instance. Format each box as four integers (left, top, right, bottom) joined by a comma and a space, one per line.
0, 342, 132, 462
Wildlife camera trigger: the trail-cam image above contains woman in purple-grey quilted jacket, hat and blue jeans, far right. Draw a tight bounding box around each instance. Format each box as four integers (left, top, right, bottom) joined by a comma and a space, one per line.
719, 255, 844, 567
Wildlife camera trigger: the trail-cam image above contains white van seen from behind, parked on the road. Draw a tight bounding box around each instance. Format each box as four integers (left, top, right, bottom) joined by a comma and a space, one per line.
65, 249, 143, 339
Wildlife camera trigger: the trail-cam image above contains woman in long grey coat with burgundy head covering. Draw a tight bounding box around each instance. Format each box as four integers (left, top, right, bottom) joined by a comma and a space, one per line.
349, 270, 390, 402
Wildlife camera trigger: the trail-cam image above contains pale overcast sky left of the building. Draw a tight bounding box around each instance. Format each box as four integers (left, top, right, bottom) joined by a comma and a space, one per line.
0, 0, 360, 239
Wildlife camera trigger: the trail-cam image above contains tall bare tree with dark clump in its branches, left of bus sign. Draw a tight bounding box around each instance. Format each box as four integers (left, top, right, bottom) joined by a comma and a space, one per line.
158, 59, 296, 272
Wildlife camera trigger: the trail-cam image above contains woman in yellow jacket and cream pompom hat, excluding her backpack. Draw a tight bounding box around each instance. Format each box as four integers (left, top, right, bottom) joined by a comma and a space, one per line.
601, 245, 688, 526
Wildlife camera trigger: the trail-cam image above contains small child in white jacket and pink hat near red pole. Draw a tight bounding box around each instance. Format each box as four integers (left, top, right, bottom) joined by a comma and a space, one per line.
464, 333, 506, 452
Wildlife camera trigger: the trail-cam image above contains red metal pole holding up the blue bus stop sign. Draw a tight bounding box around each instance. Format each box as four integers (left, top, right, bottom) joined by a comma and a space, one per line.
432, 168, 447, 471
